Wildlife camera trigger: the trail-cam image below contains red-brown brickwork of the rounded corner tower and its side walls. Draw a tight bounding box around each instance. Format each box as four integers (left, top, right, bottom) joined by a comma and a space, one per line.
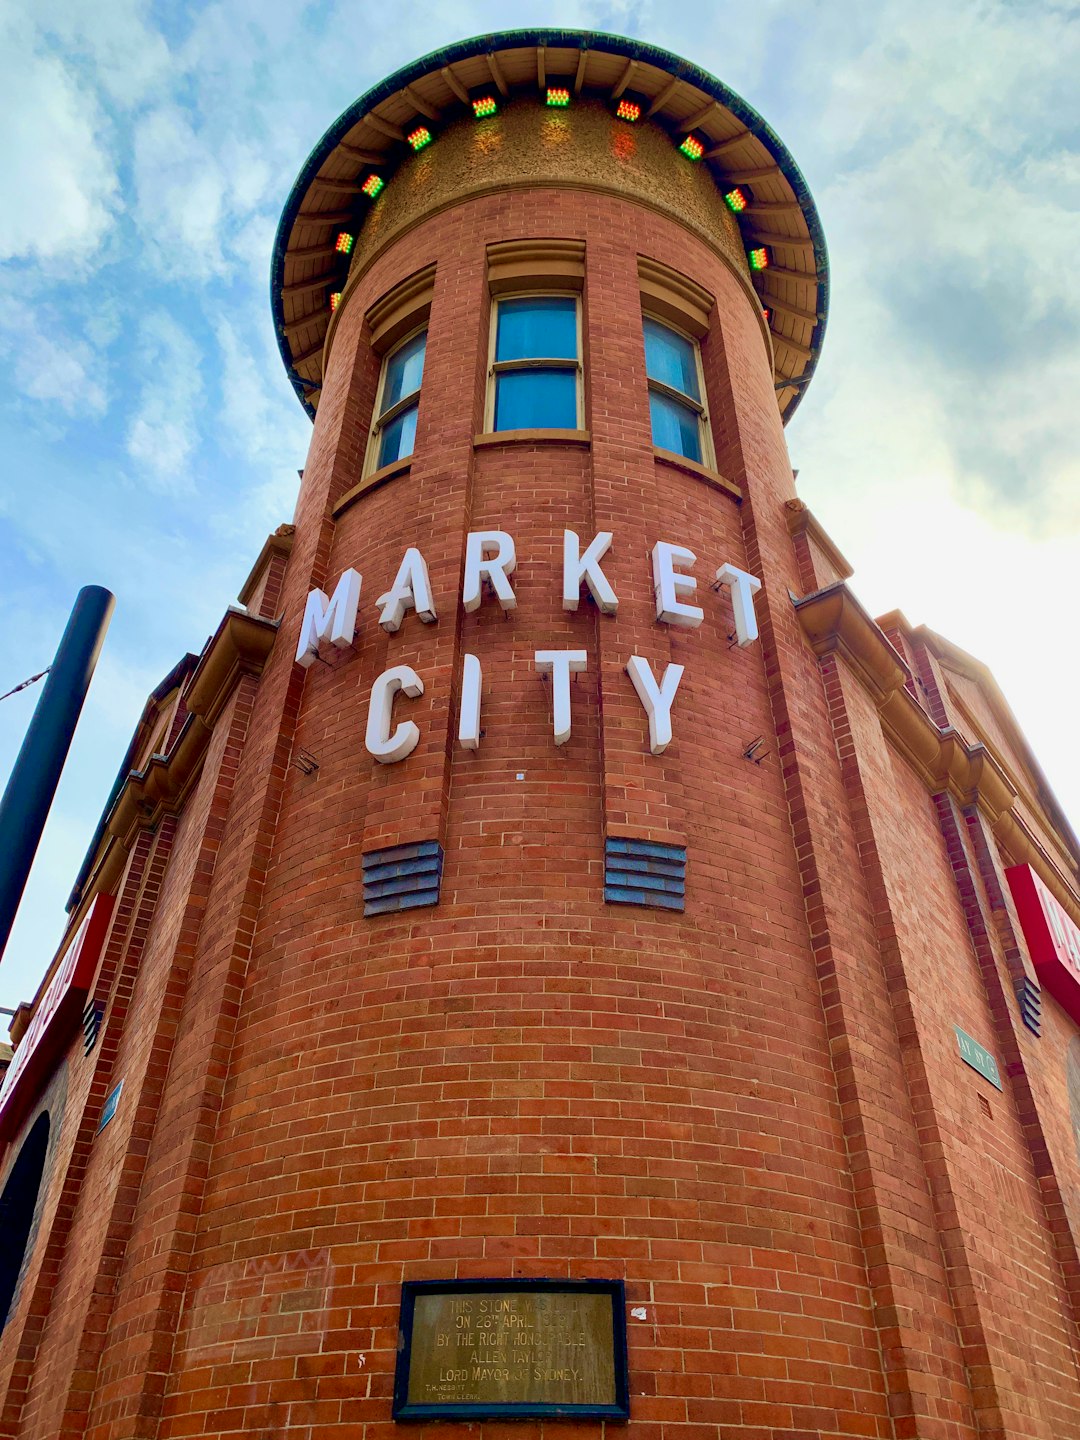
0, 151, 1080, 1440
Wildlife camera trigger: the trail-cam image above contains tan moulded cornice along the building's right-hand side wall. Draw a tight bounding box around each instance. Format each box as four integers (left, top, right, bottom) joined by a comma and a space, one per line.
795, 580, 1080, 924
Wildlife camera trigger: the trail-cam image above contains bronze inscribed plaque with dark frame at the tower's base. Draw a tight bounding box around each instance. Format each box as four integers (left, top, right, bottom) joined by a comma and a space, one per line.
393, 1280, 629, 1420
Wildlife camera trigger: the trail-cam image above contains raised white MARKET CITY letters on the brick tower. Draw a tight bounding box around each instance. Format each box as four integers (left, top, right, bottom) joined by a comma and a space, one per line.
297, 530, 762, 765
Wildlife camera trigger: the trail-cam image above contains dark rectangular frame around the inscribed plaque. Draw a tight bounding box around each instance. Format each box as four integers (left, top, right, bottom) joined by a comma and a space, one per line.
392, 1276, 629, 1421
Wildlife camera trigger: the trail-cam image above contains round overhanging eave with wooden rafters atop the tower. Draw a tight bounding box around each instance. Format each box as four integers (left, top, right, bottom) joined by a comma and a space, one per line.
271, 30, 829, 420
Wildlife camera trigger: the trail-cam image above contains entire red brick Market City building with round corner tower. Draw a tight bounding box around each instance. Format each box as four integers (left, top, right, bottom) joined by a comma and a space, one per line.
0, 32, 1080, 1440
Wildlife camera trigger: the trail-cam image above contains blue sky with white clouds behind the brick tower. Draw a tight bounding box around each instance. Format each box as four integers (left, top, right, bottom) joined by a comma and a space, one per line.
0, 0, 1080, 1007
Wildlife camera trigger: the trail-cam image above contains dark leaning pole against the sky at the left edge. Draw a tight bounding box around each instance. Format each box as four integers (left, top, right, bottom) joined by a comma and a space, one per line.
0, 585, 117, 955
